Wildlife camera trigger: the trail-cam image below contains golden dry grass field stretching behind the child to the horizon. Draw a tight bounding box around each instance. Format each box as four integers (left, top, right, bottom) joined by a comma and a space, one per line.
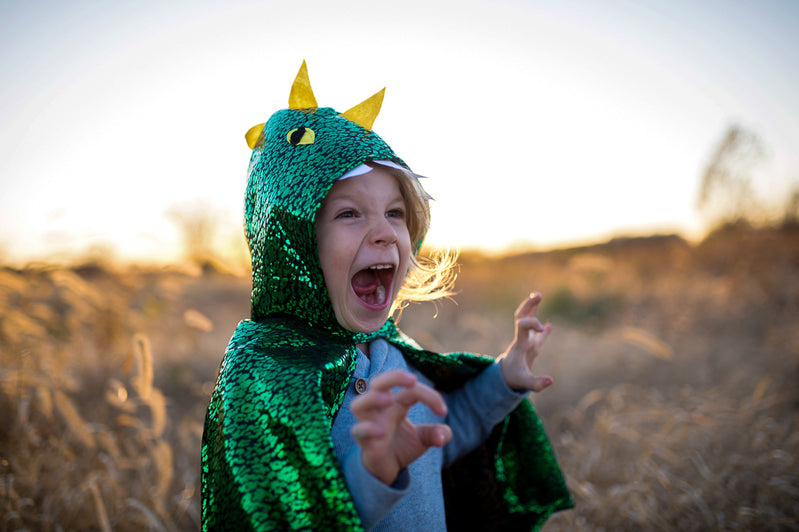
0, 223, 799, 531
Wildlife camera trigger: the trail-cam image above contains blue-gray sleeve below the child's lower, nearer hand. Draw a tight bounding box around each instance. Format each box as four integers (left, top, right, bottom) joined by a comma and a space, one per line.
342, 445, 411, 530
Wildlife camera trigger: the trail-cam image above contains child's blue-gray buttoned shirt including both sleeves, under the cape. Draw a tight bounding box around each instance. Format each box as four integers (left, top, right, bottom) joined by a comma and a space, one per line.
331, 339, 528, 531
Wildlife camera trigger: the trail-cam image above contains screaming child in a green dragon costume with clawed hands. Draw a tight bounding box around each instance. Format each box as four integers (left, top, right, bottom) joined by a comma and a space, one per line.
202, 62, 571, 530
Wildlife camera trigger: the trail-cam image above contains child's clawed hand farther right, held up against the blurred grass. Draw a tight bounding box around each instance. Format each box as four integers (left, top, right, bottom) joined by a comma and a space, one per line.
499, 293, 552, 392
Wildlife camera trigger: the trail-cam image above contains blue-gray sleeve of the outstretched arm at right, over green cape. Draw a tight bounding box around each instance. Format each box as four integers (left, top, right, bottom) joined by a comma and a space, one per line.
444, 362, 529, 467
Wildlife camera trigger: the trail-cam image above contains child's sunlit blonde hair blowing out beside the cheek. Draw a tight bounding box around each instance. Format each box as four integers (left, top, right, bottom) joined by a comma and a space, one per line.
376, 163, 458, 311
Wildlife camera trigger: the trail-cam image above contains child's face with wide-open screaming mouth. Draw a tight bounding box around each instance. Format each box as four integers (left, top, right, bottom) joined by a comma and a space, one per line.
316, 167, 411, 332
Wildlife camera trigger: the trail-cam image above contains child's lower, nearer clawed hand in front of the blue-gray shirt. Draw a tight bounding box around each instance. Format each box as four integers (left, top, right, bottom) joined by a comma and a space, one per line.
350, 370, 452, 485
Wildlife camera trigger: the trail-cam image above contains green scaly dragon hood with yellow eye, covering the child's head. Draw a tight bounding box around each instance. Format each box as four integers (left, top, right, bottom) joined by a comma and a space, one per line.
245, 63, 407, 336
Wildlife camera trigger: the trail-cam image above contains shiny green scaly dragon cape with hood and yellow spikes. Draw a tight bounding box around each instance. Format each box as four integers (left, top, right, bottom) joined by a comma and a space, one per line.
202, 62, 572, 530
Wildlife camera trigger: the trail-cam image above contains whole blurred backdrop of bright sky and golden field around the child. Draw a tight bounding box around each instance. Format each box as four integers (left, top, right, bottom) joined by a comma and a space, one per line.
0, 0, 799, 530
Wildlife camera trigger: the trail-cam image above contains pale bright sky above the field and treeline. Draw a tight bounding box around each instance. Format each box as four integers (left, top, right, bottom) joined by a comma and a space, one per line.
0, 0, 799, 261
